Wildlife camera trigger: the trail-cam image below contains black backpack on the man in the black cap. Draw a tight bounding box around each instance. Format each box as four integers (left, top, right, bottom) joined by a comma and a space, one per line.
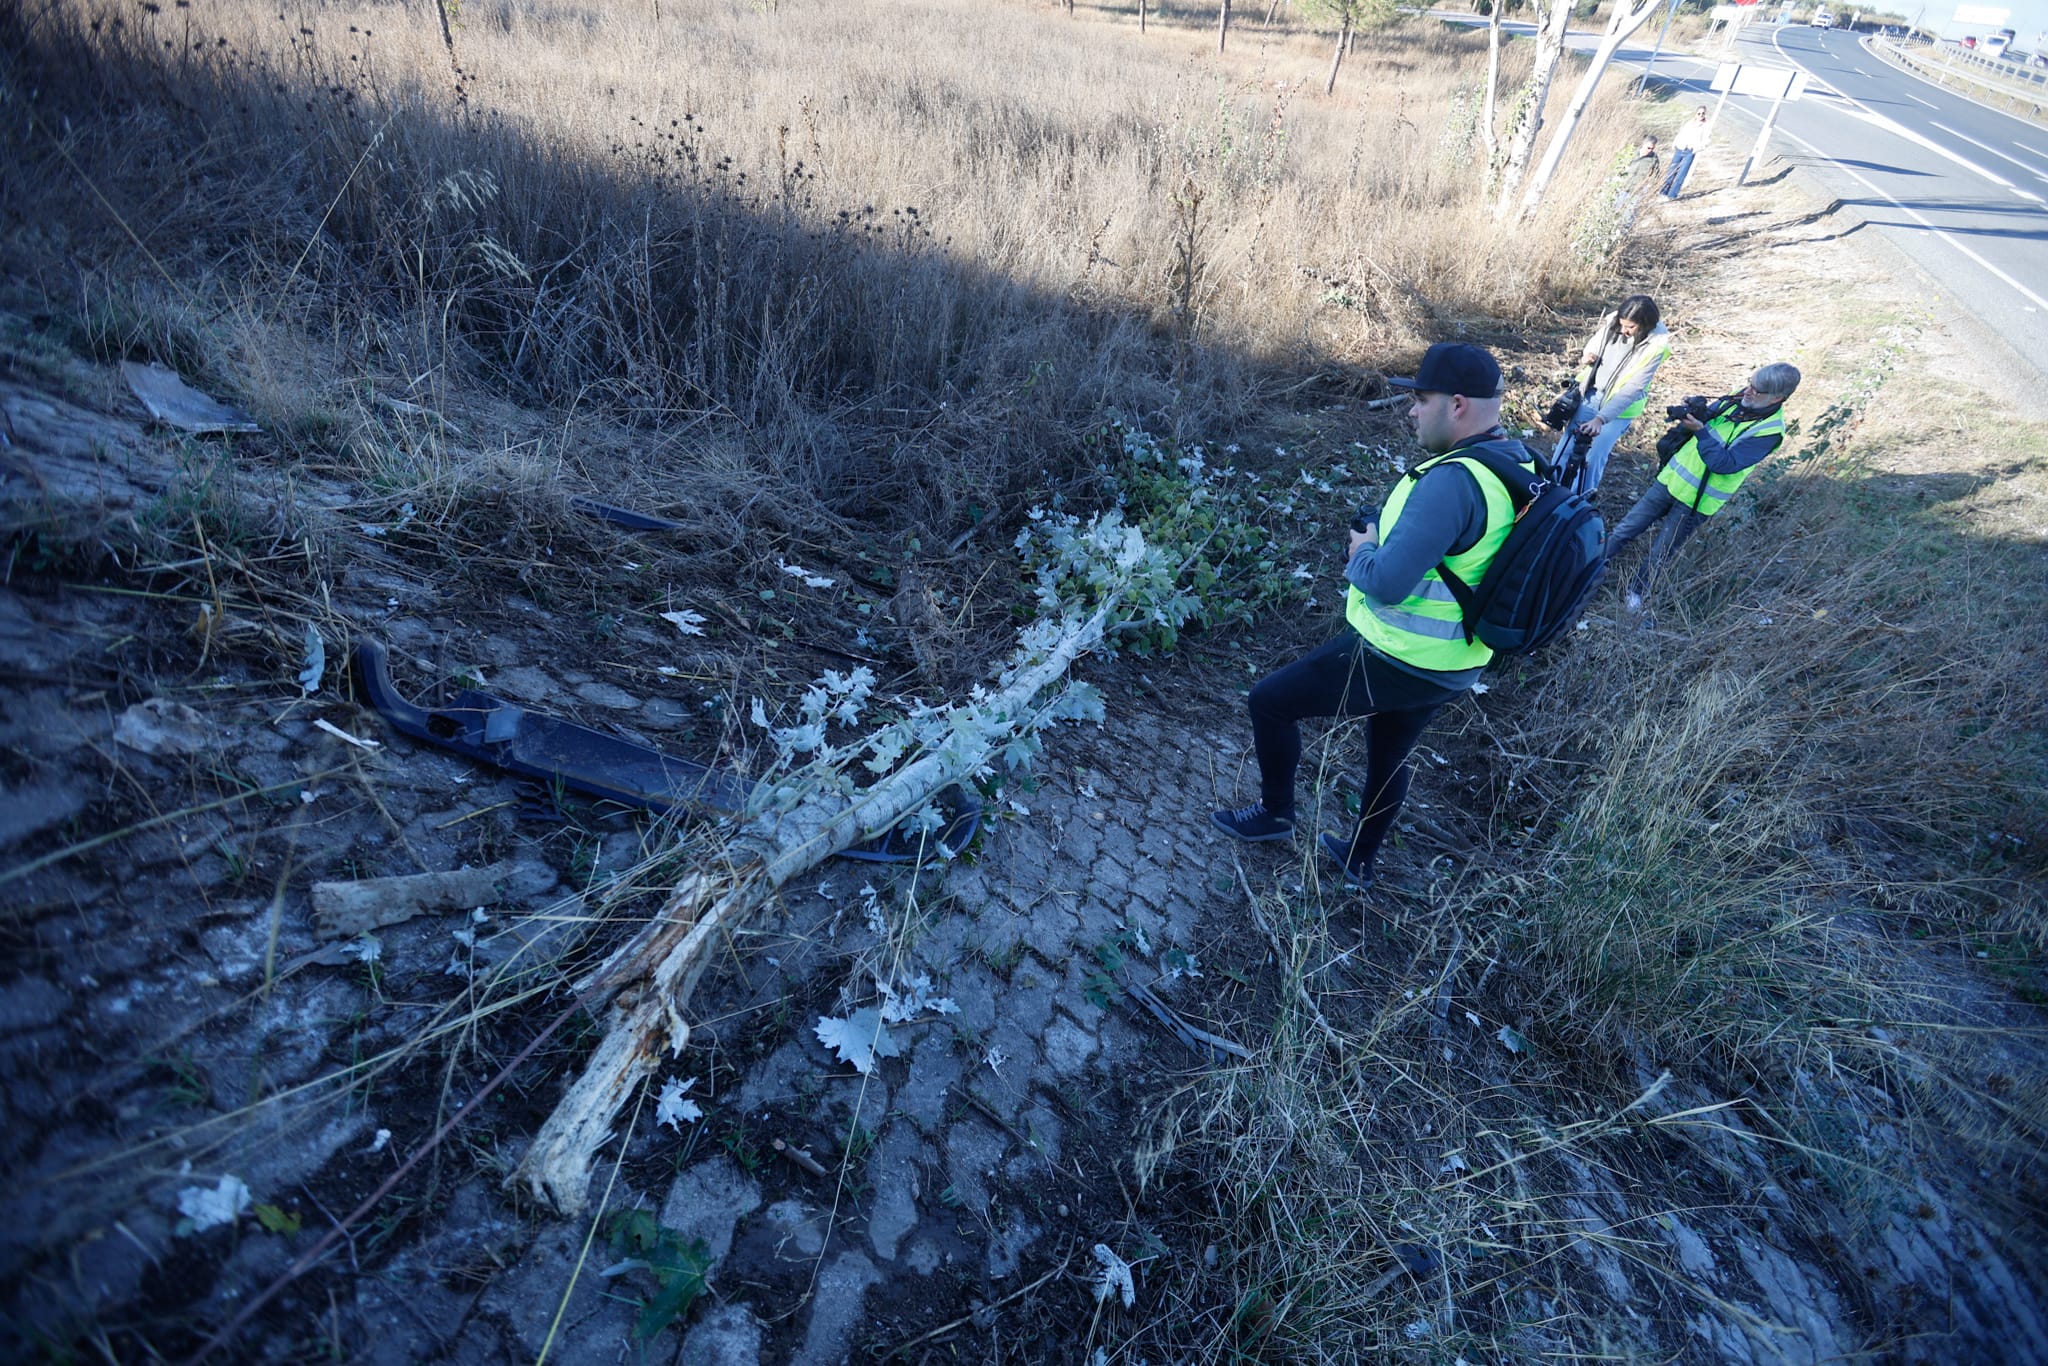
1409, 442, 1608, 655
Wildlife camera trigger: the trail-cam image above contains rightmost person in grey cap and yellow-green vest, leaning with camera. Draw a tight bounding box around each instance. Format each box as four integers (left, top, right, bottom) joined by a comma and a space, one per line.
1606, 360, 1798, 612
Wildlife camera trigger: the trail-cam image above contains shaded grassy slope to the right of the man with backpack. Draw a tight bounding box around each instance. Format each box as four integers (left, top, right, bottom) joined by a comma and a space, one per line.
1135, 305, 2048, 1360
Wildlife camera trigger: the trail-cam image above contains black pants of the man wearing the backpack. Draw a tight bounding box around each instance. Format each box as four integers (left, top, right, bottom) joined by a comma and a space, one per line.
1247, 631, 1458, 870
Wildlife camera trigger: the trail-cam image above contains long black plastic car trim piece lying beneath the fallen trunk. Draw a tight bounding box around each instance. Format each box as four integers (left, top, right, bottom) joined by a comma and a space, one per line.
352, 641, 981, 862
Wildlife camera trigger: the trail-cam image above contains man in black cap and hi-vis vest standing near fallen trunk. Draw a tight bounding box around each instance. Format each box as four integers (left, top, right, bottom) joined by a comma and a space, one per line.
1210, 342, 1536, 889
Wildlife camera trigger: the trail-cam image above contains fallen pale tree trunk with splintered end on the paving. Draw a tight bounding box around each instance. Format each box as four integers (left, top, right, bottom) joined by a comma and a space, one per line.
520, 602, 1114, 1214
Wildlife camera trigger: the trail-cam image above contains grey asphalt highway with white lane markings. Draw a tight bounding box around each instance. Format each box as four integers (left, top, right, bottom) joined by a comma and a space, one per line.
1624, 25, 2048, 391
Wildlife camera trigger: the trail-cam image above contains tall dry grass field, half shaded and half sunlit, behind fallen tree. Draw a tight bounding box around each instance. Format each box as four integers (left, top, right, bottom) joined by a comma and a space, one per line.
8, 0, 1632, 565
